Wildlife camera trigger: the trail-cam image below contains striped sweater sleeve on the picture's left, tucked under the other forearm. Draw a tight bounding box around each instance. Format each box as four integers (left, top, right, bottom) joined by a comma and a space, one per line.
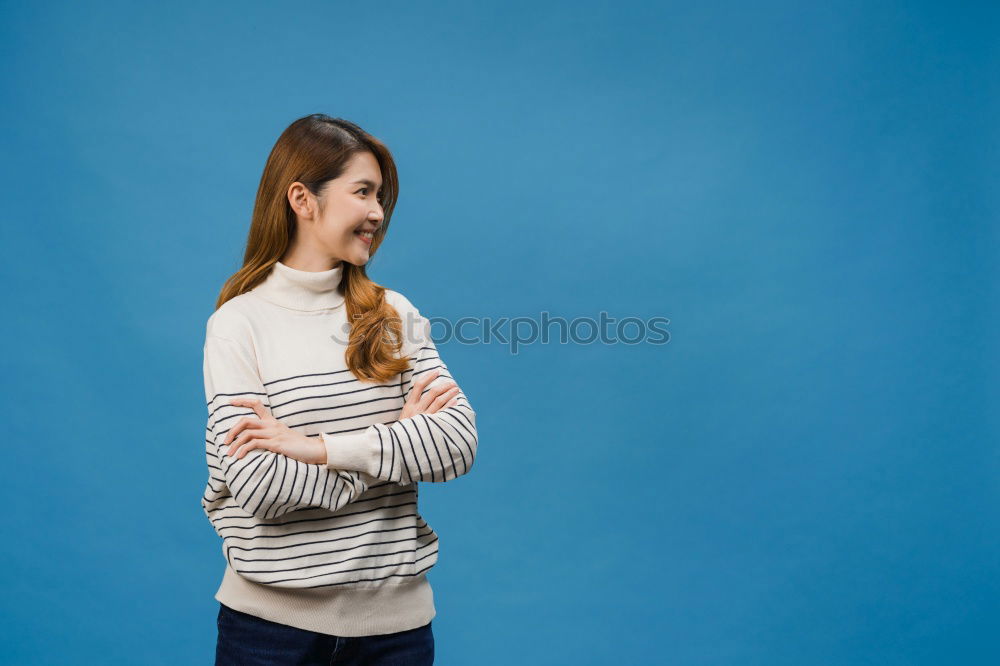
204, 333, 370, 519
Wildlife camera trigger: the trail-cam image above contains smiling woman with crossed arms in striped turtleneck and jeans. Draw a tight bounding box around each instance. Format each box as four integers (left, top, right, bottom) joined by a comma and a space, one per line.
202, 114, 478, 664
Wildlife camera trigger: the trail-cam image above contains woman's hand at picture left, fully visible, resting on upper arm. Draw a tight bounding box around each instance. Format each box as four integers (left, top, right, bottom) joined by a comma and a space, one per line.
223, 398, 326, 465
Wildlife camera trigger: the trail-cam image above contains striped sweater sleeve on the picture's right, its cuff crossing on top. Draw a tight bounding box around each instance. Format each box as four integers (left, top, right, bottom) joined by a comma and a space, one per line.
322, 301, 479, 485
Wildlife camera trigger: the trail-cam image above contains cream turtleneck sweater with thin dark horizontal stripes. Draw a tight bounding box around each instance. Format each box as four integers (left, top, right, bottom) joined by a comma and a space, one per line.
201, 262, 478, 636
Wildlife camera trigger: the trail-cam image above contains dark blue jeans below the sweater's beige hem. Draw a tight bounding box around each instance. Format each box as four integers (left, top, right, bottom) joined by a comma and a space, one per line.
215, 604, 434, 666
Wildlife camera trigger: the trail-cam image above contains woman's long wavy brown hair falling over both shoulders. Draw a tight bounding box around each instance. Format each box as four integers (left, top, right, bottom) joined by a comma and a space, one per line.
215, 113, 409, 382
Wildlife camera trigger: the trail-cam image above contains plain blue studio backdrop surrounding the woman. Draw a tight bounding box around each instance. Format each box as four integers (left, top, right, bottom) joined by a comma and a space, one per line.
0, 1, 1000, 666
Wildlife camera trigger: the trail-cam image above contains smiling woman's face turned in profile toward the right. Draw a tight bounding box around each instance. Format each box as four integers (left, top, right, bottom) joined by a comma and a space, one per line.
299, 151, 383, 266
